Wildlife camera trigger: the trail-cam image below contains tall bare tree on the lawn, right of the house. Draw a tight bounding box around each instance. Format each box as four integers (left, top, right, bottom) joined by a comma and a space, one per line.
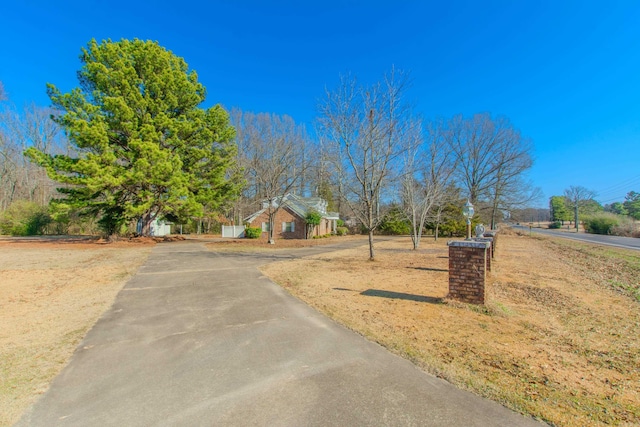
320, 70, 413, 260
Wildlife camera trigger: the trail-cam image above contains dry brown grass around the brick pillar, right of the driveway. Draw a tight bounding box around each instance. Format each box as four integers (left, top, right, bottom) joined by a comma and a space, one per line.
262, 233, 640, 426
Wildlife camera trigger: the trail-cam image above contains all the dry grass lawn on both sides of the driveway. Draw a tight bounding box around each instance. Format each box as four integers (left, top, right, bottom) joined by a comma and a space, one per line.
0, 232, 640, 426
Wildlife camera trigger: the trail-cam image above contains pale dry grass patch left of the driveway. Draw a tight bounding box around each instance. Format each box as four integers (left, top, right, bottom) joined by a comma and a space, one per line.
0, 242, 152, 426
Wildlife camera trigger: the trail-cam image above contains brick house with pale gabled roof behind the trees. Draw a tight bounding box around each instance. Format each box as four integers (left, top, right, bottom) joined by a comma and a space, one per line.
244, 193, 339, 239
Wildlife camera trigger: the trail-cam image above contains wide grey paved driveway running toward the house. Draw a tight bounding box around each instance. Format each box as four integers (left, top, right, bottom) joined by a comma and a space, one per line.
18, 242, 541, 427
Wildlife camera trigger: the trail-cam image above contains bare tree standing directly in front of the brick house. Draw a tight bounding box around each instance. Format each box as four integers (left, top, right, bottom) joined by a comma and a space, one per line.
231, 110, 309, 243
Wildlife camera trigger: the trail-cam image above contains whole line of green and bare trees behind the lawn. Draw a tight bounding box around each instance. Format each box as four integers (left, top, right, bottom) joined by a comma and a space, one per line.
0, 40, 539, 258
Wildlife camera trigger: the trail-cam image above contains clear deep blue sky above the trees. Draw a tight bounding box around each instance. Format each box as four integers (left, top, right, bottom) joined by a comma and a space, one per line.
0, 0, 640, 206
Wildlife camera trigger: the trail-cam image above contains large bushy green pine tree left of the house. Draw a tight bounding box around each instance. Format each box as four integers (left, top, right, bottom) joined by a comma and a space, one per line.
26, 39, 237, 235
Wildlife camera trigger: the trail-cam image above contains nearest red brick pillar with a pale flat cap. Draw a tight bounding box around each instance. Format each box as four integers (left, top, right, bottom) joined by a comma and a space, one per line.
447, 240, 491, 304
